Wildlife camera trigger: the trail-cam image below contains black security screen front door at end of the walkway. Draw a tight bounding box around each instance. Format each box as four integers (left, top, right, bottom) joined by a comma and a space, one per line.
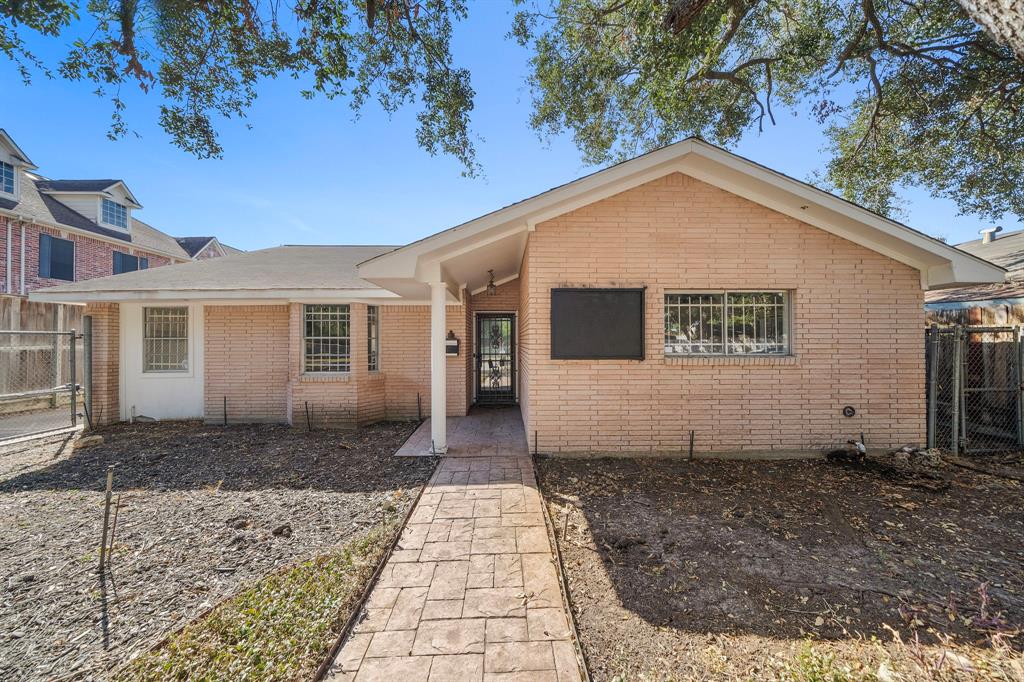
476, 312, 515, 404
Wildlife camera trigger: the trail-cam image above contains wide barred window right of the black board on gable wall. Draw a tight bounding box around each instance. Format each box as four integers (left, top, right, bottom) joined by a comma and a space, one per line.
665, 291, 790, 355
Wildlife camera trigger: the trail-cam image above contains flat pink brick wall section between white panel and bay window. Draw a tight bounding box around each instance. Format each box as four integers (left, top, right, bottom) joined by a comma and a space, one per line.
203, 305, 289, 423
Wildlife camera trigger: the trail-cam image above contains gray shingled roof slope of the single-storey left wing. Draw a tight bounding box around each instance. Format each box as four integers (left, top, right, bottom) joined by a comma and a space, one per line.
31, 246, 395, 302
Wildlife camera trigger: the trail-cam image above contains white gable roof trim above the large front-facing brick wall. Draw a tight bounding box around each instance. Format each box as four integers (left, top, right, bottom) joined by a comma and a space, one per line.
358, 138, 1006, 289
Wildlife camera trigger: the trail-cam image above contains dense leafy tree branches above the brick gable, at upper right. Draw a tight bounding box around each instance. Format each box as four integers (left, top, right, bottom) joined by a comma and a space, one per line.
513, 0, 1024, 217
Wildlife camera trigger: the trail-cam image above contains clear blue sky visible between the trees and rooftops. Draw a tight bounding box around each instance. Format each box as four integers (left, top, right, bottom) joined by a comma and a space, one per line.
0, 2, 1022, 249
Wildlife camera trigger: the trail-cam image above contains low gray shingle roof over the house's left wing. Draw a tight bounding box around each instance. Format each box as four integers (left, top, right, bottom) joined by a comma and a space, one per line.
36, 246, 397, 300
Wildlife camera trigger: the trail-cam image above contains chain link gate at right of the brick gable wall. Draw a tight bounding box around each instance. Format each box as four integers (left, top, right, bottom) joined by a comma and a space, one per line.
925, 326, 1024, 455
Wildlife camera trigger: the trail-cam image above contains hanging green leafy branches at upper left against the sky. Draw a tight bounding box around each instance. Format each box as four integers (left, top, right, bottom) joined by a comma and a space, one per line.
0, 0, 477, 169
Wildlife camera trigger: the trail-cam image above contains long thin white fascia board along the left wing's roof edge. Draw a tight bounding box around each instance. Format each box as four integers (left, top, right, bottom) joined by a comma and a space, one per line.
29, 289, 400, 303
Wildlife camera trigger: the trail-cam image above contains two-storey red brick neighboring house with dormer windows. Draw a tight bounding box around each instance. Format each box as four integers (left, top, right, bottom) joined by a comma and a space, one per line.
0, 130, 236, 296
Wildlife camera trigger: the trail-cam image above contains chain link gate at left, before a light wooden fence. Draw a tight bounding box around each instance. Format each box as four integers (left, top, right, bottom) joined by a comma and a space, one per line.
0, 330, 84, 442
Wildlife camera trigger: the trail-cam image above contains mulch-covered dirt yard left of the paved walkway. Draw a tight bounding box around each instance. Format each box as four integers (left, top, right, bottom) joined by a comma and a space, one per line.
0, 423, 434, 680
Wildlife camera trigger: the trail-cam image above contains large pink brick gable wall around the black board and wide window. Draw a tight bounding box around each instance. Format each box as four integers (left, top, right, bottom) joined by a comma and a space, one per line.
520, 174, 925, 453
